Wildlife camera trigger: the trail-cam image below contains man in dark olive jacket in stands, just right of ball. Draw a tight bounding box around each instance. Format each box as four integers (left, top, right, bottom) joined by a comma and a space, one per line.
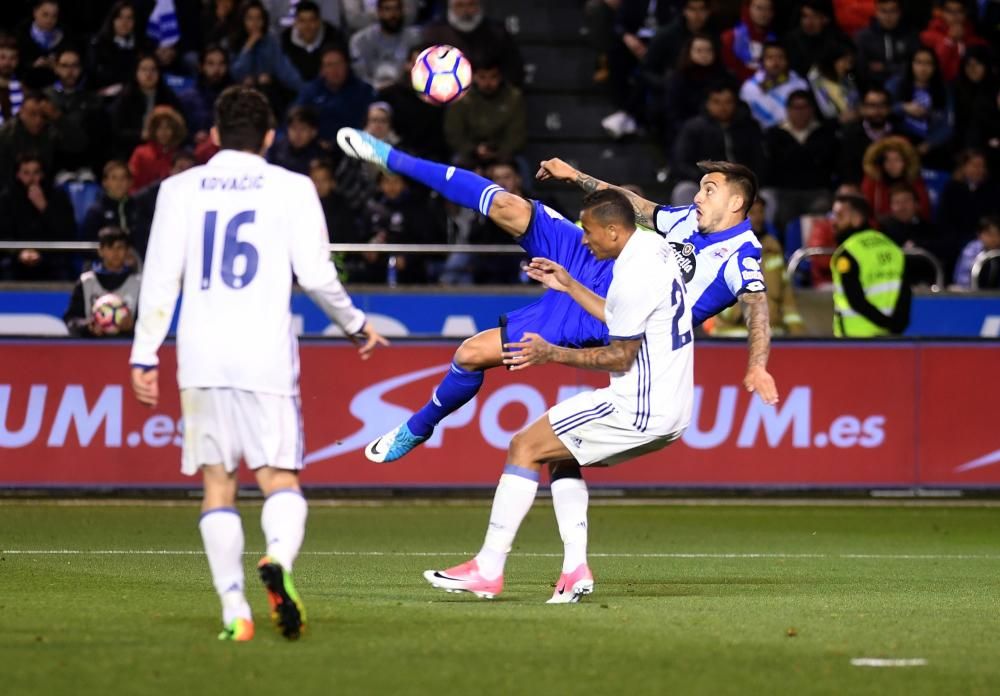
444, 56, 527, 164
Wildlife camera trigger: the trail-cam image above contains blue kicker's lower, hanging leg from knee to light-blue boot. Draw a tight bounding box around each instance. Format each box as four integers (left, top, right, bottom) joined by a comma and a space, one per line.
365, 329, 502, 463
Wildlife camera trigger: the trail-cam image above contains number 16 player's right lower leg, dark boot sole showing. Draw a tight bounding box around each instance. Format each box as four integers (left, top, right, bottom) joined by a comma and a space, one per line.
257, 486, 307, 640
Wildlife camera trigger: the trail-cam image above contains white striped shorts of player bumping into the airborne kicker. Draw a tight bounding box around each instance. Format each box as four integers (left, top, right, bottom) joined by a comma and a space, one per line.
549, 389, 683, 466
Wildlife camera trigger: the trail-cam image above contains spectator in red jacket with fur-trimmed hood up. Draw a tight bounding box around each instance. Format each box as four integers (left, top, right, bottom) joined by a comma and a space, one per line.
861, 135, 931, 220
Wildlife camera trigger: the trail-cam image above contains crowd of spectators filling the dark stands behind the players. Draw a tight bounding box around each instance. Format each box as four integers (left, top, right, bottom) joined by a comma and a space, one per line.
0, 0, 1000, 286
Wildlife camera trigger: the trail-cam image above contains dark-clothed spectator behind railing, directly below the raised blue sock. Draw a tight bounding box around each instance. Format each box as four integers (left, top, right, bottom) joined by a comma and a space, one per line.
351, 171, 444, 285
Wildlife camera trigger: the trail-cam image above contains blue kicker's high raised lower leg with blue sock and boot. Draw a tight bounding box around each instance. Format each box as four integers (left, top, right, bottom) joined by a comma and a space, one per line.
337, 128, 508, 218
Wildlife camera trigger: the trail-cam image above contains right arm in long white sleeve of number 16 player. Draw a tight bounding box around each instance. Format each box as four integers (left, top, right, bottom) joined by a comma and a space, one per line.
290, 178, 389, 359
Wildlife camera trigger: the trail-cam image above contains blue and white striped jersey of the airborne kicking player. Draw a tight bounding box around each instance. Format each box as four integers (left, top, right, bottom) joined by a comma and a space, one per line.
653, 205, 767, 326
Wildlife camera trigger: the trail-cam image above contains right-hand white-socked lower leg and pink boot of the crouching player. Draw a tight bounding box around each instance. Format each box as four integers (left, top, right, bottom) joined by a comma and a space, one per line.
548, 462, 594, 604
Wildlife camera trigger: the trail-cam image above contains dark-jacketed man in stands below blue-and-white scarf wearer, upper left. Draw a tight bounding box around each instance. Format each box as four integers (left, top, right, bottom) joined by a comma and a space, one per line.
45, 46, 107, 180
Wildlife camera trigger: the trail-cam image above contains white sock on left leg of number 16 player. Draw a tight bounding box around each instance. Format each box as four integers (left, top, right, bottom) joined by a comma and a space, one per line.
198, 508, 252, 626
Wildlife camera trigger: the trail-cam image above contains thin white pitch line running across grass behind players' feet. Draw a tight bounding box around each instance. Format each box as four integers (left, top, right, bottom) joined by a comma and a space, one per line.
0, 549, 1000, 561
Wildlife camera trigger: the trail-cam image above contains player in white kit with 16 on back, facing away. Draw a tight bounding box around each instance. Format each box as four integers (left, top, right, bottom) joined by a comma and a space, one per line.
130, 87, 386, 641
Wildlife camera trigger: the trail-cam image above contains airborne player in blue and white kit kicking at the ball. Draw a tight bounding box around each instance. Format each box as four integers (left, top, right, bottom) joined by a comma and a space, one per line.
337, 128, 777, 462
